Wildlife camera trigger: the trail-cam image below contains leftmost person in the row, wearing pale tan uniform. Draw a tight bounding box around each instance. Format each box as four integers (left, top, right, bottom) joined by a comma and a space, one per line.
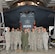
5, 27, 10, 53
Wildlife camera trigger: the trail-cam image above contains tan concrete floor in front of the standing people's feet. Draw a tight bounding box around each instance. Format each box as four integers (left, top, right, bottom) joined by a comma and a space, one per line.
0, 48, 55, 54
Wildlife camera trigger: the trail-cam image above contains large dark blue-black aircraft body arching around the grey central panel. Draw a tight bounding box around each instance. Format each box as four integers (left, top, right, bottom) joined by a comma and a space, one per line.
4, 5, 55, 28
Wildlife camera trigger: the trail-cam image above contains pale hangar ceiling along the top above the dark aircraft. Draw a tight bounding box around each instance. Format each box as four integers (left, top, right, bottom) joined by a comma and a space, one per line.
2, 0, 55, 8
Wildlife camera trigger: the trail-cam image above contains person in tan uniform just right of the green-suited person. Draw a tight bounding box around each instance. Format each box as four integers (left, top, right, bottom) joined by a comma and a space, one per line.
30, 28, 37, 51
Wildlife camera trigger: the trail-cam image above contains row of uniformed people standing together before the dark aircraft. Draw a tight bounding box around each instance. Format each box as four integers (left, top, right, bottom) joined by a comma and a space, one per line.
5, 26, 49, 52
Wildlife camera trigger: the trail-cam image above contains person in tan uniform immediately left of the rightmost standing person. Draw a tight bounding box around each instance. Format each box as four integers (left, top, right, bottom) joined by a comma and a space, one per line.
37, 27, 43, 51
